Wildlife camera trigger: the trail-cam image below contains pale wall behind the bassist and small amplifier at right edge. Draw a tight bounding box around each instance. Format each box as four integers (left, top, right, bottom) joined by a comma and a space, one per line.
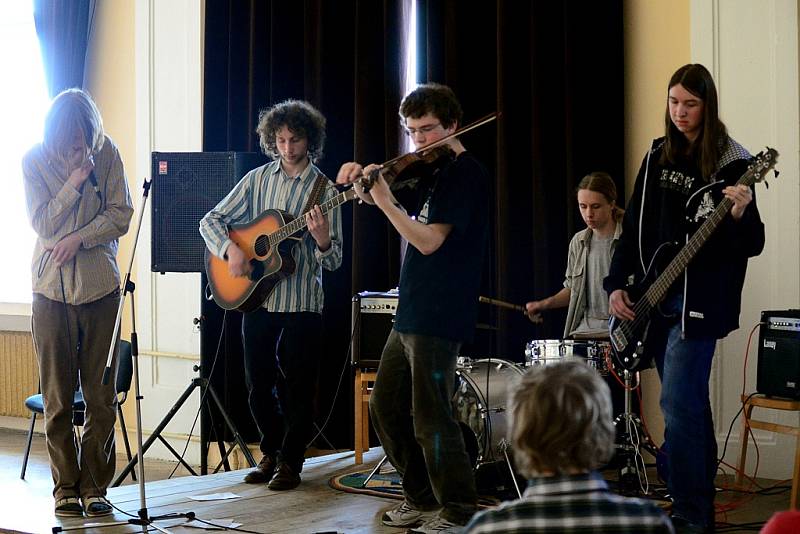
691, 0, 800, 479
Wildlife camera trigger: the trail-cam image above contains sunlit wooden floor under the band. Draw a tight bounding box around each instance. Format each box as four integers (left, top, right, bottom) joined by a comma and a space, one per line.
0, 429, 789, 534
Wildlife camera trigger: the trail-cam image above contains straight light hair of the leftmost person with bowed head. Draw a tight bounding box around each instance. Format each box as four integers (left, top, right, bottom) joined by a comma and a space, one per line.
43, 88, 105, 161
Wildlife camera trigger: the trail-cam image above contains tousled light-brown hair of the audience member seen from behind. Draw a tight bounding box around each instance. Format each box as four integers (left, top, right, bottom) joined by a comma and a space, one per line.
508, 359, 614, 478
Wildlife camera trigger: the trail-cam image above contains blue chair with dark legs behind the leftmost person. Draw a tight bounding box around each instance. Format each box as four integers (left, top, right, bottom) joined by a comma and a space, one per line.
19, 339, 136, 480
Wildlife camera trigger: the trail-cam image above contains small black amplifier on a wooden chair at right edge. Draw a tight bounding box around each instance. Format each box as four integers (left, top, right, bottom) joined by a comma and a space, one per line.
756, 310, 800, 399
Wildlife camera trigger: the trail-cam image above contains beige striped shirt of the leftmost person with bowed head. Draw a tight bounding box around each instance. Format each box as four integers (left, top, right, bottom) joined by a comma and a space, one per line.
22, 136, 133, 306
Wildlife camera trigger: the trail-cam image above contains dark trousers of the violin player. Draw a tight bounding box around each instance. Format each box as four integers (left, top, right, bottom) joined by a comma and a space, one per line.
369, 330, 478, 524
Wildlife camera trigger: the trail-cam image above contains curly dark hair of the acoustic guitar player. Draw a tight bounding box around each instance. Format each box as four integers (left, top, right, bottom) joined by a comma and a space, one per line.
256, 100, 325, 161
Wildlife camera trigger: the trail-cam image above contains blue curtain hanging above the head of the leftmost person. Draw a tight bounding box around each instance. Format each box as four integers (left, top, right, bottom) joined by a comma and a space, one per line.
33, 0, 95, 98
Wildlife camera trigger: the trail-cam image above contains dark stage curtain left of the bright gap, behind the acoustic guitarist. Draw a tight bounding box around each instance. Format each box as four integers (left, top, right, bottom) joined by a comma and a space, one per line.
203, 0, 410, 448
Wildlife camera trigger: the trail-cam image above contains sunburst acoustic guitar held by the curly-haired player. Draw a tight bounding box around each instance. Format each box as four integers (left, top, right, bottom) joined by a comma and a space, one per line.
206, 188, 357, 312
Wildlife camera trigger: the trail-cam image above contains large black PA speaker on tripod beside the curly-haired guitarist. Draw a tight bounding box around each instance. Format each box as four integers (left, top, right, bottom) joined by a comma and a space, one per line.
150, 152, 269, 273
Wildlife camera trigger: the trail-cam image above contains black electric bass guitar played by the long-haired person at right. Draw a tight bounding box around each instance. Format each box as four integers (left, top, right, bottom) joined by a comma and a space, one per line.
608, 147, 778, 372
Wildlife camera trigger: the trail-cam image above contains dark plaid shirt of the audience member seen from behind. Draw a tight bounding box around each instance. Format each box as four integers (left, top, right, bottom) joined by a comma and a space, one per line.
463, 472, 674, 534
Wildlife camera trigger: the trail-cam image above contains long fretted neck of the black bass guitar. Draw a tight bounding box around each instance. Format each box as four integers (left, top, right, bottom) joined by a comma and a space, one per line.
642, 170, 756, 311
